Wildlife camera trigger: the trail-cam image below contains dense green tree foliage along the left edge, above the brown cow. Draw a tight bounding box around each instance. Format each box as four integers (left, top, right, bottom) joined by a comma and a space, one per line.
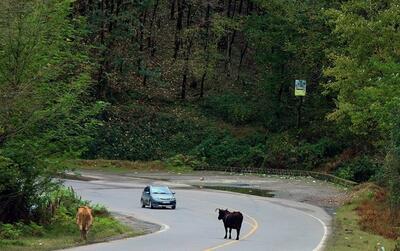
0, 0, 103, 222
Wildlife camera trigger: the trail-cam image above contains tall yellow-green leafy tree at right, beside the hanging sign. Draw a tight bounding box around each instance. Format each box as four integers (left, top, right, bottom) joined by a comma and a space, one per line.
325, 0, 400, 212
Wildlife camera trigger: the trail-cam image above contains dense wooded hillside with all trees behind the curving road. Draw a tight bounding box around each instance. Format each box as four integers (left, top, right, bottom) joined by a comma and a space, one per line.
0, 0, 400, 243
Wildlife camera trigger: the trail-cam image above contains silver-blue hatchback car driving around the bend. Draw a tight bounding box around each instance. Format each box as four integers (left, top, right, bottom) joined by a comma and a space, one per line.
140, 186, 176, 209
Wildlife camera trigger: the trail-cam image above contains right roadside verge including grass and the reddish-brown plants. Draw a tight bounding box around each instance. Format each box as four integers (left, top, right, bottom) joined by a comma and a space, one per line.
326, 183, 400, 251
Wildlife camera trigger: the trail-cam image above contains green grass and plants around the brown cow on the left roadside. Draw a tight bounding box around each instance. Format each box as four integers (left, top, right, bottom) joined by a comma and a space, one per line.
0, 189, 142, 251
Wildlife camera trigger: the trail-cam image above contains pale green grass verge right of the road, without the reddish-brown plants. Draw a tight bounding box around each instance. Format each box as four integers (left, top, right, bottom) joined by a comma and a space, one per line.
326, 184, 395, 251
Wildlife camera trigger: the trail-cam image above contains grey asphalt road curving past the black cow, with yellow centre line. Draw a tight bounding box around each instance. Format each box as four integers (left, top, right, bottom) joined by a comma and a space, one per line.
65, 180, 331, 251
